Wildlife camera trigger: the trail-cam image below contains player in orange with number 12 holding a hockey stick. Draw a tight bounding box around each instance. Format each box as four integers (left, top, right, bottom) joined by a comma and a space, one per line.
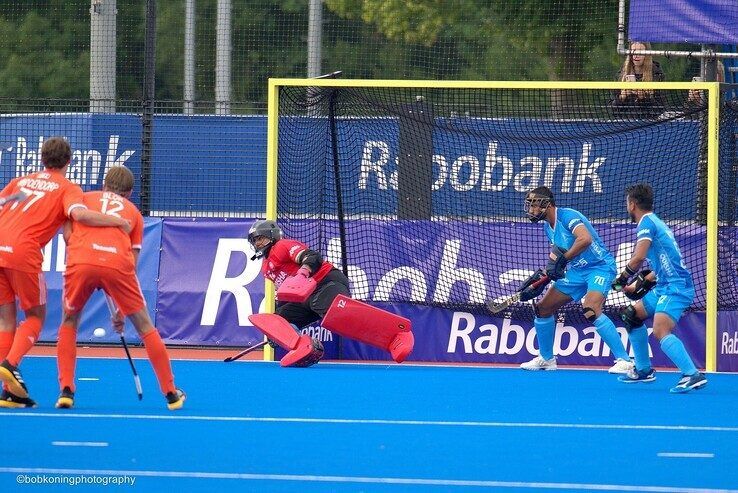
56, 166, 185, 410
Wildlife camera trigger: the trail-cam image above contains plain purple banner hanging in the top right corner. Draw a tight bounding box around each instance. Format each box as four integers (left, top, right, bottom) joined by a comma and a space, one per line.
628, 0, 738, 45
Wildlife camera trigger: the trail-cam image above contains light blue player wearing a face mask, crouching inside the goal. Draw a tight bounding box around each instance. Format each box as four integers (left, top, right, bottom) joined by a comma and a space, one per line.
520, 187, 633, 374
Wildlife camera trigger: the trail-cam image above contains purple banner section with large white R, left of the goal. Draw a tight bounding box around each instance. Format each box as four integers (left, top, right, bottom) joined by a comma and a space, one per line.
156, 219, 264, 346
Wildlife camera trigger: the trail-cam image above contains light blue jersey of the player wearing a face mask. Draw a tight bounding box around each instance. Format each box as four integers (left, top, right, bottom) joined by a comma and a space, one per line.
543, 207, 615, 269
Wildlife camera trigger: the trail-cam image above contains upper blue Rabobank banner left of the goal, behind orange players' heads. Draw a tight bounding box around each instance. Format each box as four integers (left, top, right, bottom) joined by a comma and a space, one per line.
0, 113, 266, 214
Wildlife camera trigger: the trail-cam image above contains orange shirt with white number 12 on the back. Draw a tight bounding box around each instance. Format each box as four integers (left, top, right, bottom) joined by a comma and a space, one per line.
67, 191, 143, 273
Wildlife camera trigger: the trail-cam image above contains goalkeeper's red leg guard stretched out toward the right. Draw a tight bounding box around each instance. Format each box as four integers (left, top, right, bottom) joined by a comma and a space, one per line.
321, 294, 415, 363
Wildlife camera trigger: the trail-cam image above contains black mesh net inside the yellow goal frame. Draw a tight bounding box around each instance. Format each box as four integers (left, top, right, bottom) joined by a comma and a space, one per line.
277, 82, 736, 317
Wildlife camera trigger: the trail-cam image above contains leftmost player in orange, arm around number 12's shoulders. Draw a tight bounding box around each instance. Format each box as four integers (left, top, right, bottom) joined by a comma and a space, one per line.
0, 137, 130, 408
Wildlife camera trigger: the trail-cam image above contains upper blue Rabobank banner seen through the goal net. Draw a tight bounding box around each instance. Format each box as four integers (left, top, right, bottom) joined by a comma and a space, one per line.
279, 117, 701, 220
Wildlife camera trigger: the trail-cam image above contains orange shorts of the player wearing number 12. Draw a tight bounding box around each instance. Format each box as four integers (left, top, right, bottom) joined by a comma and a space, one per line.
64, 264, 146, 317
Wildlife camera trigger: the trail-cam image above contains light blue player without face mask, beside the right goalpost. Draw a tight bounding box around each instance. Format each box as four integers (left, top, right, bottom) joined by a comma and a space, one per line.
612, 184, 707, 394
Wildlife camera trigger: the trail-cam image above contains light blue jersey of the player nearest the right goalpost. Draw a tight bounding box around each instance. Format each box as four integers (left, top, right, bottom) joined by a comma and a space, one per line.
636, 212, 694, 291
